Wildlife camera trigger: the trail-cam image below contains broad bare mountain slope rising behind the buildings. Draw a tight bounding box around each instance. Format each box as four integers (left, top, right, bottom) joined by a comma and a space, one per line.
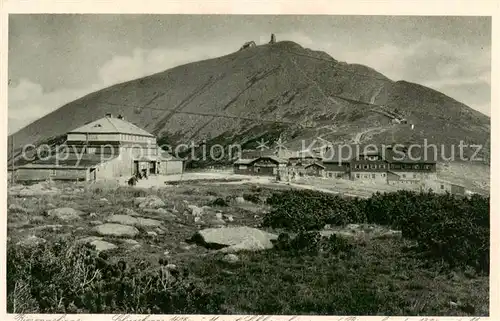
9, 41, 490, 162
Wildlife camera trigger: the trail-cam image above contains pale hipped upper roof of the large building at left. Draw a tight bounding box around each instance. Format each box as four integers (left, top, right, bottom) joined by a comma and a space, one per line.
69, 117, 154, 137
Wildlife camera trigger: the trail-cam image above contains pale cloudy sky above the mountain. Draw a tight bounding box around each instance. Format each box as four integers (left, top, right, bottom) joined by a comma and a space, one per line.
8, 14, 491, 133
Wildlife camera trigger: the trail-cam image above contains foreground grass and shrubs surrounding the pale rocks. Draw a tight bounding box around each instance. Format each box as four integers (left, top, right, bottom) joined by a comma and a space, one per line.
7, 182, 489, 315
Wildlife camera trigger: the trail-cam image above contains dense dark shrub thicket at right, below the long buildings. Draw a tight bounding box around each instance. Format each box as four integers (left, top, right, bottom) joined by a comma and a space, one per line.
263, 190, 489, 272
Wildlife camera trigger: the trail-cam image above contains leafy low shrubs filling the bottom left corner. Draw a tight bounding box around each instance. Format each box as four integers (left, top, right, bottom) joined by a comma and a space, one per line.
7, 241, 221, 314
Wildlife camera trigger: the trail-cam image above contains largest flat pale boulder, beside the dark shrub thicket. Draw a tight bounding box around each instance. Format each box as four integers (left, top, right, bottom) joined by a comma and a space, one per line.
191, 226, 278, 252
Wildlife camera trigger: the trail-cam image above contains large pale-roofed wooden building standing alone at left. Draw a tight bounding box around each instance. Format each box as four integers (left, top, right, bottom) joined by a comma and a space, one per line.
15, 114, 183, 181
